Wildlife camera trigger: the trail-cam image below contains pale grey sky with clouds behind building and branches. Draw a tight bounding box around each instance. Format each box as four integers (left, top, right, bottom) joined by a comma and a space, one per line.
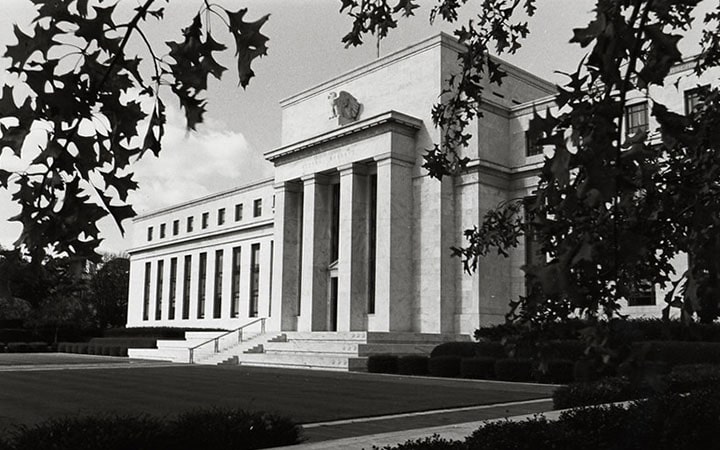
0, 0, 716, 253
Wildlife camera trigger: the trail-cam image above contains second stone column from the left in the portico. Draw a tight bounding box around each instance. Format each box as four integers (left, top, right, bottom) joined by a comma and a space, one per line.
298, 174, 332, 331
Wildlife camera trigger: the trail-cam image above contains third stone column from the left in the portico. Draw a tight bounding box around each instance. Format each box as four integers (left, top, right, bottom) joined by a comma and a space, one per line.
338, 164, 369, 331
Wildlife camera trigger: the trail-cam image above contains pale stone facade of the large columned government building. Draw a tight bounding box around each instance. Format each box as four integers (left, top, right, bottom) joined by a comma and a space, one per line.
128, 34, 716, 334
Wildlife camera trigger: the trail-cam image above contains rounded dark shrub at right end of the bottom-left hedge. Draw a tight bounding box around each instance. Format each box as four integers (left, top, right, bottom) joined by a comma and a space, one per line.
167, 408, 302, 450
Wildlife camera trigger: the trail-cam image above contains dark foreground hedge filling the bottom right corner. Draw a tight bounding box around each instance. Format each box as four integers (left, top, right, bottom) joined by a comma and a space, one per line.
375, 390, 720, 450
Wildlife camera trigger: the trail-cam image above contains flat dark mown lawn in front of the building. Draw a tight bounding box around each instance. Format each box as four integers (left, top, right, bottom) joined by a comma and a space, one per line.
0, 365, 552, 429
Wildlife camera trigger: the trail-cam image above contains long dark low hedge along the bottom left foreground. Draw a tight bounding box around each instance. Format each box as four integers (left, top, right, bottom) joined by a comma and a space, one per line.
0, 408, 302, 450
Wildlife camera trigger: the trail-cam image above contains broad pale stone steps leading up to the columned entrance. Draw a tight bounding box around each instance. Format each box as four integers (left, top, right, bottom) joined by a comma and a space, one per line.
214, 331, 470, 371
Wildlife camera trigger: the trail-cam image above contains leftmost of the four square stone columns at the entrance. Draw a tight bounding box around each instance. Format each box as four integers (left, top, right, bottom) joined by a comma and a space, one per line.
272, 182, 302, 331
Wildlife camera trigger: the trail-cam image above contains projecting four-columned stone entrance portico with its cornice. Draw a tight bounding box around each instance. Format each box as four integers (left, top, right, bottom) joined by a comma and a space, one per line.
266, 111, 422, 331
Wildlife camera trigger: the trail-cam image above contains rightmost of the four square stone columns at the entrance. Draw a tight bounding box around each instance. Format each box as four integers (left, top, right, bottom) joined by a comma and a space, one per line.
368, 157, 415, 331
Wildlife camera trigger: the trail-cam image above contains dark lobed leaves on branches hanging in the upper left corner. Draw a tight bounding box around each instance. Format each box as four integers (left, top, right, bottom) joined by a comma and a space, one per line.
0, 0, 268, 259
